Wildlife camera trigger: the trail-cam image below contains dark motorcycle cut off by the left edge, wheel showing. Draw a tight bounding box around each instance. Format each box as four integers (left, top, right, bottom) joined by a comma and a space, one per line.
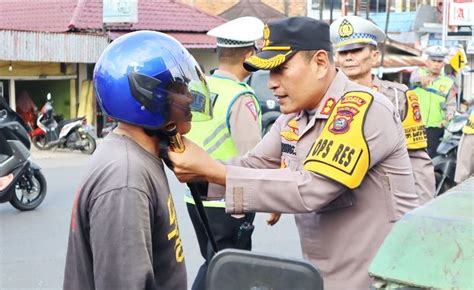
0, 98, 47, 211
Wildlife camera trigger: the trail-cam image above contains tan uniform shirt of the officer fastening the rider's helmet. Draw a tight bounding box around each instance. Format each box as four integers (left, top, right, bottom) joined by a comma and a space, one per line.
209, 72, 418, 289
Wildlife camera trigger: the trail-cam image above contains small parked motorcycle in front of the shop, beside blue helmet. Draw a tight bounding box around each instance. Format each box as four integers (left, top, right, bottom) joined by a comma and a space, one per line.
31, 93, 97, 154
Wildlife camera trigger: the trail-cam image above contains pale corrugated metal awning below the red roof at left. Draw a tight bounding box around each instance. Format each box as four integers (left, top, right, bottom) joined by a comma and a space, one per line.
0, 30, 108, 63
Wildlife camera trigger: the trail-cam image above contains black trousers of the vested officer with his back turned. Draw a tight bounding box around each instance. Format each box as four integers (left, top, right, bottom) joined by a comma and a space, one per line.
186, 203, 255, 290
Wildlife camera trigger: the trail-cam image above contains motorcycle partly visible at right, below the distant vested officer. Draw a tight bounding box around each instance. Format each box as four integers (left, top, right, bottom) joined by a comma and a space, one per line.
433, 113, 468, 197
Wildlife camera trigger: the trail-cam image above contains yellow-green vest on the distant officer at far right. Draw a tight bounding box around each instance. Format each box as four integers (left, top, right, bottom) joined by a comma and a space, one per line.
413, 87, 446, 128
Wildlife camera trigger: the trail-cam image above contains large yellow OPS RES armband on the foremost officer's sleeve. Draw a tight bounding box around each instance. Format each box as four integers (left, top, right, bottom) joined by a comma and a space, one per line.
304, 91, 374, 189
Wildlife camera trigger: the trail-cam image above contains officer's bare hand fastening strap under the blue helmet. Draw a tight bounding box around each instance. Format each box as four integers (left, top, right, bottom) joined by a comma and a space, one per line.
168, 137, 226, 185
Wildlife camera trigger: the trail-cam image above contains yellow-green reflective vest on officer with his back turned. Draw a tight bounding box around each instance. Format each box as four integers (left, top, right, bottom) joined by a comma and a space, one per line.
184, 76, 262, 207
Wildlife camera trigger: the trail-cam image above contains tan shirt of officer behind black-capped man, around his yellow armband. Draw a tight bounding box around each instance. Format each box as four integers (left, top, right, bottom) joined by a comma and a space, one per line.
372, 77, 436, 205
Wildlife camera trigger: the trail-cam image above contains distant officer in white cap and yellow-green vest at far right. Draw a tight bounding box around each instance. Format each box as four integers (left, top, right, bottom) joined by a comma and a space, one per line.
410, 45, 457, 158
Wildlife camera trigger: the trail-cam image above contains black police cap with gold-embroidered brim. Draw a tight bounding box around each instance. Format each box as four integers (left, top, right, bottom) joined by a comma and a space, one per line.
244, 16, 331, 71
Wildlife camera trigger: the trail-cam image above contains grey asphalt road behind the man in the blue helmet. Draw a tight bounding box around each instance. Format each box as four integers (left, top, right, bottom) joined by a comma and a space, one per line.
0, 145, 301, 290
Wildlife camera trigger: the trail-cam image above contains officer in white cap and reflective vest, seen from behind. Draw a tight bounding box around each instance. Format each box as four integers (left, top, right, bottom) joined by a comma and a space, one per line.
185, 17, 263, 289
